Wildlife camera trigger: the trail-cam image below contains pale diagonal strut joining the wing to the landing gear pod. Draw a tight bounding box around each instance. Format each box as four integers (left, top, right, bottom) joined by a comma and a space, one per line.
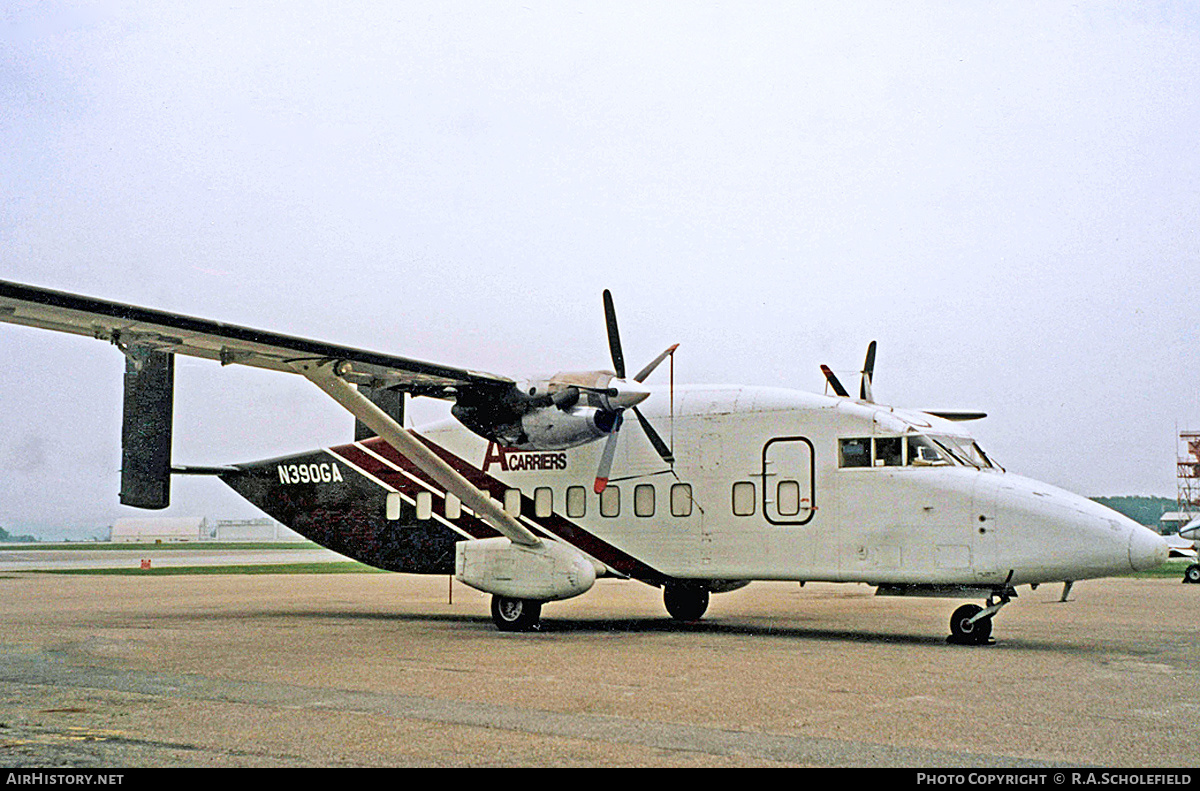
292, 360, 542, 547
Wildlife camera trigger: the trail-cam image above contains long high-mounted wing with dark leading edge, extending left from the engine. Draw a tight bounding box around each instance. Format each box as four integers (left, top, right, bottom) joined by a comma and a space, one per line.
0, 281, 514, 397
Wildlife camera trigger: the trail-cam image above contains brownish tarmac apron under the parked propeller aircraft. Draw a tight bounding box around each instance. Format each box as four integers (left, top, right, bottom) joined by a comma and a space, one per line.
0, 573, 1200, 768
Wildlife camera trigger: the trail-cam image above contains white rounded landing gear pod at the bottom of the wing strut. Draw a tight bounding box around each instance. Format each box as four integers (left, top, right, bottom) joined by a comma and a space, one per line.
455, 538, 596, 601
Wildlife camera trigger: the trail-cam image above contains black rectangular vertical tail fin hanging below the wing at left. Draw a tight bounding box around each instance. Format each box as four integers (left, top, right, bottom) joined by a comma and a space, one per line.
121, 346, 175, 509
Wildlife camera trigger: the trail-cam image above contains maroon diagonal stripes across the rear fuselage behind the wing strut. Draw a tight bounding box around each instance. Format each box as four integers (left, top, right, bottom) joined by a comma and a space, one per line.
343, 432, 668, 585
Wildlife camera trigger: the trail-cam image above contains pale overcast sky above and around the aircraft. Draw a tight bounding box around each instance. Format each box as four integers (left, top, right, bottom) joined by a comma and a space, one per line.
0, 0, 1200, 534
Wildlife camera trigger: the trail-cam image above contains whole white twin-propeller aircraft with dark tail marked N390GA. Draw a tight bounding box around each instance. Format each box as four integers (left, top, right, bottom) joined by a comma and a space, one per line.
0, 281, 1168, 643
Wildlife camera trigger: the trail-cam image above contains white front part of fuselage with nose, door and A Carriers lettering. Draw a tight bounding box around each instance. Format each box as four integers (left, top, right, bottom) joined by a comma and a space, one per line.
421, 386, 1166, 587
